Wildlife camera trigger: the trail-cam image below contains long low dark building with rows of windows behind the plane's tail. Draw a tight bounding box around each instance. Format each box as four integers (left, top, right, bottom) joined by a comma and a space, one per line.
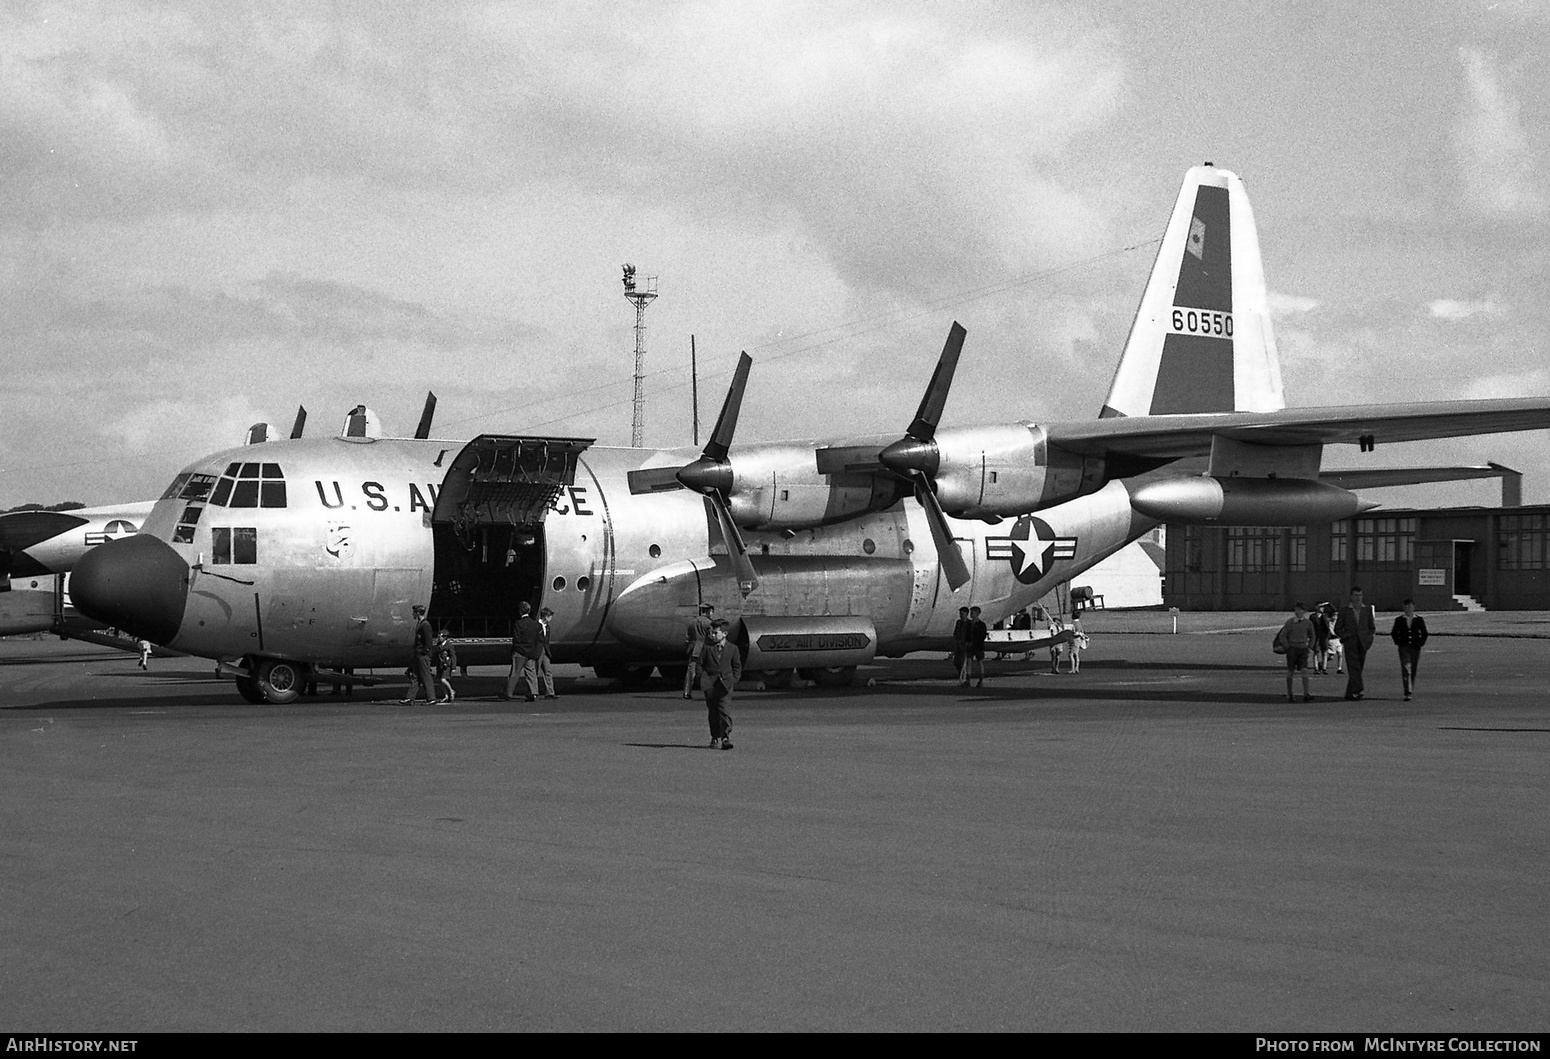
1163, 474, 1550, 611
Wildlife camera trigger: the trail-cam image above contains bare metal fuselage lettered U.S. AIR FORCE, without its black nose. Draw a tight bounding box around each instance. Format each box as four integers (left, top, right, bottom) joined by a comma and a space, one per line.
130, 437, 1152, 668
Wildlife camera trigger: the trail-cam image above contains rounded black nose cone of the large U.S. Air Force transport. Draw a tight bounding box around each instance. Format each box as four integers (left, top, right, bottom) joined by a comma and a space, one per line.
70, 533, 189, 643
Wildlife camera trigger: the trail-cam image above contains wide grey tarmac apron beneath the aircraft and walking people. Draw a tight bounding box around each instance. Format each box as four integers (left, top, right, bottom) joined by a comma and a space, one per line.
0, 630, 1550, 1034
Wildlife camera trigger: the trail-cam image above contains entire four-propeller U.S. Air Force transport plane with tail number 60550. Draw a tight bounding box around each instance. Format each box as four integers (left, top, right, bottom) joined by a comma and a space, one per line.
73, 164, 1550, 702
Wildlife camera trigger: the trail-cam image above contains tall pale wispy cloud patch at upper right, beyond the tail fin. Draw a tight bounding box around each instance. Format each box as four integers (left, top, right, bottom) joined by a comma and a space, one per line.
1454, 48, 1550, 217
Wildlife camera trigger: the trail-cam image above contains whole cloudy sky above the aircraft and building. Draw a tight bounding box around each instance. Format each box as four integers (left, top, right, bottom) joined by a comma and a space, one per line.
0, 0, 1550, 509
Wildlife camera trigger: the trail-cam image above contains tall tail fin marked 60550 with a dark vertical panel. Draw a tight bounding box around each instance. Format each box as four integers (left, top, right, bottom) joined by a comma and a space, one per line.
1099, 164, 1287, 419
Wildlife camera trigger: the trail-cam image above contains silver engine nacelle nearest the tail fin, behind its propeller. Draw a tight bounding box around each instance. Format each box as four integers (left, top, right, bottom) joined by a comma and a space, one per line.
933, 423, 1104, 518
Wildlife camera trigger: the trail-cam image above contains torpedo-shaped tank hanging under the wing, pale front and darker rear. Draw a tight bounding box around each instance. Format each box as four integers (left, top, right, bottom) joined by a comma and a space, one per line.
1130, 478, 1376, 526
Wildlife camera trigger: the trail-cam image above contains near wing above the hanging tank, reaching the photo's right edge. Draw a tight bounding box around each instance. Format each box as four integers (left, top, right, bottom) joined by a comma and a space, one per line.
1045, 397, 1550, 459
